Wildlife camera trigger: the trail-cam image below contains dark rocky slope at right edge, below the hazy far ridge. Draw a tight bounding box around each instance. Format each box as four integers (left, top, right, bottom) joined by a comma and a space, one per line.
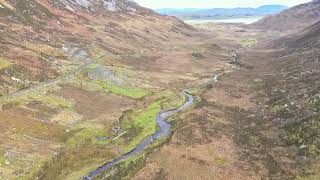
256, 18, 320, 179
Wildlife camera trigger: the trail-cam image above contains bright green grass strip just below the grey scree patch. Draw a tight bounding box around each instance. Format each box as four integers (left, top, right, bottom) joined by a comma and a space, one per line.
97, 81, 150, 99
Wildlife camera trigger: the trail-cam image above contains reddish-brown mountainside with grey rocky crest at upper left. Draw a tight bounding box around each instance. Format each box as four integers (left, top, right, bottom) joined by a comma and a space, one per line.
0, 0, 193, 95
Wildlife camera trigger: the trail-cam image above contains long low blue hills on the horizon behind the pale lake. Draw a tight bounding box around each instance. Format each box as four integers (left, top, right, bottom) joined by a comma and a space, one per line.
156, 5, 288, 19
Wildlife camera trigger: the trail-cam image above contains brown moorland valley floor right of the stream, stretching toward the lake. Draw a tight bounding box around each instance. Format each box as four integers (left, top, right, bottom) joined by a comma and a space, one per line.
134, 24, 319, 180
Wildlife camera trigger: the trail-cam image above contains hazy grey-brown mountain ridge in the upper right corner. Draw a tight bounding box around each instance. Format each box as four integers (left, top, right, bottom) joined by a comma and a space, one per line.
250, 0, 320, 31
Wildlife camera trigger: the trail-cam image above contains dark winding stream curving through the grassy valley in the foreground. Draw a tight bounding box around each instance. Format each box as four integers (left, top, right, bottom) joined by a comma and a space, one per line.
83, 91, 194, 180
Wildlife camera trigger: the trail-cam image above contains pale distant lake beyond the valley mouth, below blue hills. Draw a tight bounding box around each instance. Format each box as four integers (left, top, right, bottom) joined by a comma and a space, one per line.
184, 16, 263, 24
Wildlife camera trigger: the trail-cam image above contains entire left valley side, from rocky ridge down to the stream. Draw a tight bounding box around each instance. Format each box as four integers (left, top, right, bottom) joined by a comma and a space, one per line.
0, 0, 204, 179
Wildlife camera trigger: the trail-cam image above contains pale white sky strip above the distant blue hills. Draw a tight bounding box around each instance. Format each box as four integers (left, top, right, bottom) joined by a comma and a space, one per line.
135, 0, 310, 9
